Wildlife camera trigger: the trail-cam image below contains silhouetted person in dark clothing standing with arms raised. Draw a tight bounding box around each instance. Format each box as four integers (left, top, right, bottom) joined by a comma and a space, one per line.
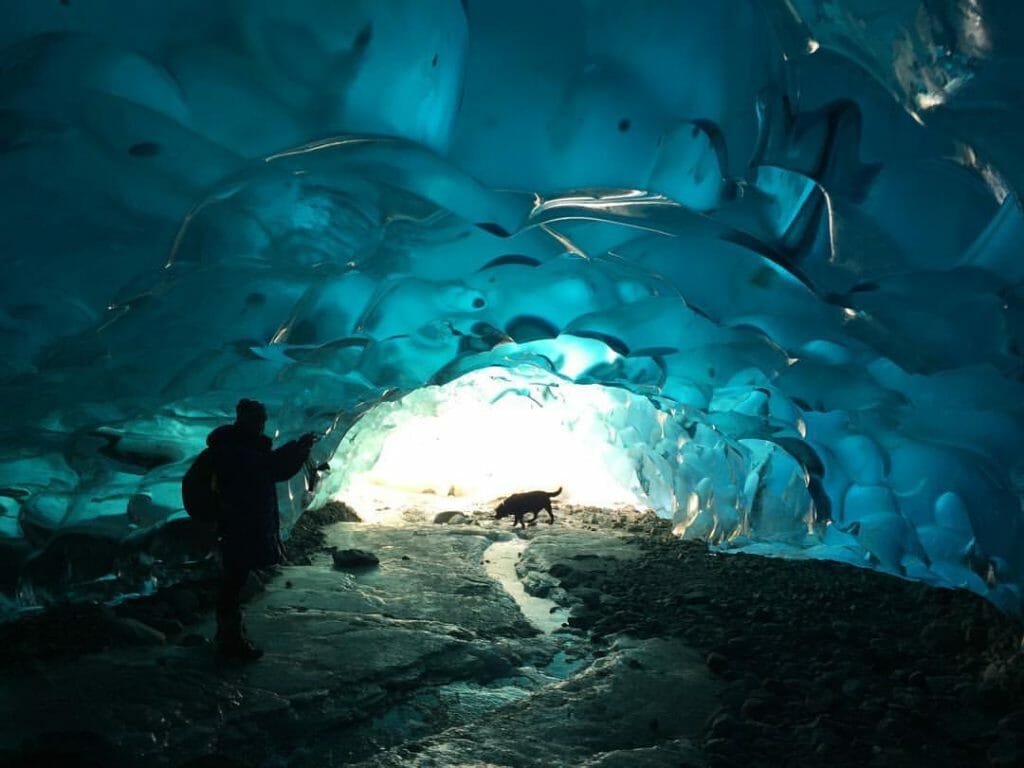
206, 398, 316, 660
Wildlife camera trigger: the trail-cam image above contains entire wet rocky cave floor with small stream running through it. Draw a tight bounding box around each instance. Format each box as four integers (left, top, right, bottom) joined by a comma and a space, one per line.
0, 508, 1024, 768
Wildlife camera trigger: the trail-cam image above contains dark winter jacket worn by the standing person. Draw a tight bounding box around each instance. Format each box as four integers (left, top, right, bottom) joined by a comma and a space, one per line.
206, 424, 309, 568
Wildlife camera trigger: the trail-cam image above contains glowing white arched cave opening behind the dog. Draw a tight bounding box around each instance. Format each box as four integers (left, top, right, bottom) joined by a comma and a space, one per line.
331, 368, 647, 522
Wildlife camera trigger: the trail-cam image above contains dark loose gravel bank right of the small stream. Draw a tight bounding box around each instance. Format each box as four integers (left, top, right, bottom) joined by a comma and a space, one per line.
559, 512, 1024, 768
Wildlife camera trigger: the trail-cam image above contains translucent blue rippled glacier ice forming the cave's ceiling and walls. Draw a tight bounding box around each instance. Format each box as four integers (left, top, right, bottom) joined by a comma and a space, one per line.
0, 0, 1024, 613
